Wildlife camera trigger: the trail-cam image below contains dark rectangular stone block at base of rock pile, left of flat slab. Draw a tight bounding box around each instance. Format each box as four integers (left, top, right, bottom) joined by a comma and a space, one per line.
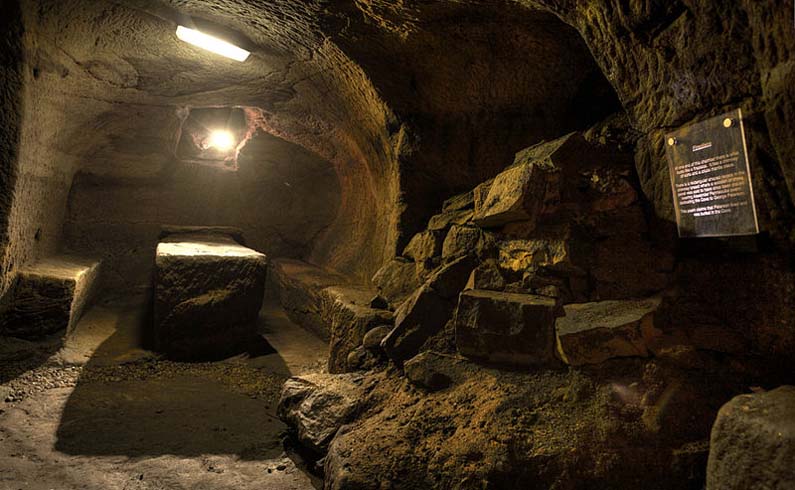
455, 289, 556, 366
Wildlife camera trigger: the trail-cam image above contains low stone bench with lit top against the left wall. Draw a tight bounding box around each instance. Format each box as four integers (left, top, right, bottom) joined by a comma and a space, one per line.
0, 255, 100, 339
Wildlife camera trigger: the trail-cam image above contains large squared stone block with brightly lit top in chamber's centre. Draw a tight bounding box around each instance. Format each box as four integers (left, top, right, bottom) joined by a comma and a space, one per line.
154, 231, 267, 360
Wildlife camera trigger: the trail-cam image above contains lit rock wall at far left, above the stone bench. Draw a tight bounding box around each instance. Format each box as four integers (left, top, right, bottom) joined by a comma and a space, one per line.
0, 2, 90, 302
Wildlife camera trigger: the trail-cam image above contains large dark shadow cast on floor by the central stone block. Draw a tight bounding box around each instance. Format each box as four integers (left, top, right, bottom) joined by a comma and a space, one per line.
55, 294, 308, 460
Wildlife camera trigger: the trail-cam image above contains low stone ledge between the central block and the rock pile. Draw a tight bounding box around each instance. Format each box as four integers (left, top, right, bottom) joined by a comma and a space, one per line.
269, 259, 392, 373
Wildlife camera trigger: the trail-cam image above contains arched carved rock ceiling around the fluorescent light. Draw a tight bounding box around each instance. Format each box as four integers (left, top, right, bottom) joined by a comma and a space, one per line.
26, 0, 609, 277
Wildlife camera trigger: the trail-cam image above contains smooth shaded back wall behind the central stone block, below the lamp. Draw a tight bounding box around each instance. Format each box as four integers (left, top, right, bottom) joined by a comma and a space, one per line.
64, 130, 340, 289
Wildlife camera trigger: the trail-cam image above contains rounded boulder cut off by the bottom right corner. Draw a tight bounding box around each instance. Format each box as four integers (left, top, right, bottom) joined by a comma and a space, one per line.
707, 386, 795, 490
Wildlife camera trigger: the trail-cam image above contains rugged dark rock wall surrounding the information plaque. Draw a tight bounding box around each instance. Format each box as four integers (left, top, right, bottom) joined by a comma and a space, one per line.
527, 0, 795, 239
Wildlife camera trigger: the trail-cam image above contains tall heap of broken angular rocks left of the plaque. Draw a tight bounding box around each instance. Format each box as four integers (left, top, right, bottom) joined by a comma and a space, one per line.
373, 133, 674, 366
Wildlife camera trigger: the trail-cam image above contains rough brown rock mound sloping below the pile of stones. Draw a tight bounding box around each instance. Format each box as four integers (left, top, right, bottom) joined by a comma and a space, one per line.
324, 353, 742, 490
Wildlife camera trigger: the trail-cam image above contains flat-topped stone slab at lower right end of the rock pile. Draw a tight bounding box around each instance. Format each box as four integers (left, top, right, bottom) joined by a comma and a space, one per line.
555, 298, 661, 366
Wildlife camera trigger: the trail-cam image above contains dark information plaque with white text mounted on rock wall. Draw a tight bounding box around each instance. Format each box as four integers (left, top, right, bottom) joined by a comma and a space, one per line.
665, 109, 759, 237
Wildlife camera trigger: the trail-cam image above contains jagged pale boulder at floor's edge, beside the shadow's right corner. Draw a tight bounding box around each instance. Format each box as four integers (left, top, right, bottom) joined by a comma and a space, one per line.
278, 374, 364, 453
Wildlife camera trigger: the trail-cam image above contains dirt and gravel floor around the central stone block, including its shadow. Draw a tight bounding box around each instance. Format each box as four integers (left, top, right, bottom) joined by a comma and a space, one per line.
0, 297, 327, 490
